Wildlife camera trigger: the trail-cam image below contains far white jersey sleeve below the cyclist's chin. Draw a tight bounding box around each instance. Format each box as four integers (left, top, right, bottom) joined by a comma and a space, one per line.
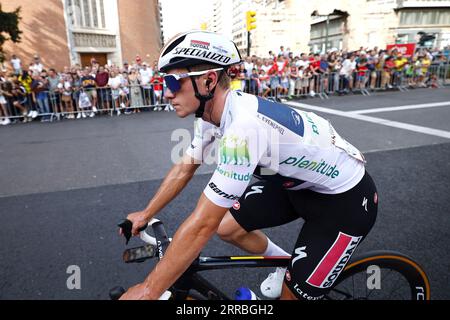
186, 119, 215, 163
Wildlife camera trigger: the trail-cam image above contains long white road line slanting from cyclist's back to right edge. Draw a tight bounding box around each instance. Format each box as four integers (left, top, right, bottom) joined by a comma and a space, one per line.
288, 102, 450, 139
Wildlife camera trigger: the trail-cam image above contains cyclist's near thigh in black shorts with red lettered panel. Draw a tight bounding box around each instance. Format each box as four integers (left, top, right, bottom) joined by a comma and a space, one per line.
285, 174, 378, 299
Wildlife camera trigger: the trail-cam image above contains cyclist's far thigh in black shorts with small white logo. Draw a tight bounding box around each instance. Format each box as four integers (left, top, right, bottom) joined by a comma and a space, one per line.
230, 180, 299, 232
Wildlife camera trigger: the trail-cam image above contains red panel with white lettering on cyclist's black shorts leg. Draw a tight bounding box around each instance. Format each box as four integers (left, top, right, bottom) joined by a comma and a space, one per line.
306, 232, 362, 288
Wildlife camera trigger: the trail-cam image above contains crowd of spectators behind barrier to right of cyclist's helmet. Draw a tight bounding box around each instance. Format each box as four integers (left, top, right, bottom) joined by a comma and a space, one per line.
231, 46, 449, 97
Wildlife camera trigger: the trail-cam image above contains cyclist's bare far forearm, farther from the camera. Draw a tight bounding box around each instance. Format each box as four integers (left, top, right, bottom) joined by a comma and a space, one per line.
144, 163, 198, 220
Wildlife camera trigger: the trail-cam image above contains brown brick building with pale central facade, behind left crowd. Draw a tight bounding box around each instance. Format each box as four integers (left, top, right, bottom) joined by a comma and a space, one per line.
1, 0, 162, 69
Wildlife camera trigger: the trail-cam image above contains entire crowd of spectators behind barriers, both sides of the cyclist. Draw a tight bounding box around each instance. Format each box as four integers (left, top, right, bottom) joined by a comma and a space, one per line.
0, 46, 450, 125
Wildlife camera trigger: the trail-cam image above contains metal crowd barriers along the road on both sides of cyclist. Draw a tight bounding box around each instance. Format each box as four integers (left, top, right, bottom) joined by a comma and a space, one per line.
0, 63, 450, 123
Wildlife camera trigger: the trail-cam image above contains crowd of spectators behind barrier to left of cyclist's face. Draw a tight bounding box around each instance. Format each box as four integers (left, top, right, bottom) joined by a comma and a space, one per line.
0, 54, 173, 125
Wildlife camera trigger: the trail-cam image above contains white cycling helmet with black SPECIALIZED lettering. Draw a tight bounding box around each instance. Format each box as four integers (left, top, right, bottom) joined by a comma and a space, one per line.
158, 30, 242, 72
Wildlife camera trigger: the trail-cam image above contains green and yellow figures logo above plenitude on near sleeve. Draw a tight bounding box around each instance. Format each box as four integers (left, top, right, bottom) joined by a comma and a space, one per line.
219, 135, 250, 167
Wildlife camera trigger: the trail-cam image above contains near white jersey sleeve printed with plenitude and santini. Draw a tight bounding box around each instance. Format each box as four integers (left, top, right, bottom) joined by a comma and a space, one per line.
203, 122, 267, 208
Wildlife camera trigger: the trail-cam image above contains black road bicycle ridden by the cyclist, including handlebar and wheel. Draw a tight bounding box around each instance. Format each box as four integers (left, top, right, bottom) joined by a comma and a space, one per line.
110, 219, 430, 300
